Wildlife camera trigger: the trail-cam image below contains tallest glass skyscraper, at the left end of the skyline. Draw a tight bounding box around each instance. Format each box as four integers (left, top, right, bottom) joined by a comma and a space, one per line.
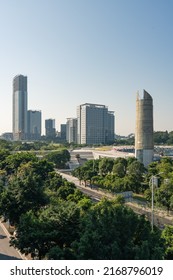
13, 75, 27, 140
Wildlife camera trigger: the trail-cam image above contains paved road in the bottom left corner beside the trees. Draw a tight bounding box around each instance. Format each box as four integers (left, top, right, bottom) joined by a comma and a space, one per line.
0, 222, 22, 260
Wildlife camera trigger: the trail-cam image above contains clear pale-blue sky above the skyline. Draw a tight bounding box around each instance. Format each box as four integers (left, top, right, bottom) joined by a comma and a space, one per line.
0, 0, 173, 135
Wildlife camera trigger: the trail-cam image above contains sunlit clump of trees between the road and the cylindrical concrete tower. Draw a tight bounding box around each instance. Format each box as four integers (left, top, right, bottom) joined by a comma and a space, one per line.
73, 158, 146, 193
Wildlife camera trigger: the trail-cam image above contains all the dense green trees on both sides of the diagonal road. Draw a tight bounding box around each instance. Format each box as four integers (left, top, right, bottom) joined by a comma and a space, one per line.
0, 139, 173, 259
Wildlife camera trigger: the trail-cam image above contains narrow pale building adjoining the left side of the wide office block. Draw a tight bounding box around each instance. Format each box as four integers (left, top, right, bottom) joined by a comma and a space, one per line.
66, 118, 77, 144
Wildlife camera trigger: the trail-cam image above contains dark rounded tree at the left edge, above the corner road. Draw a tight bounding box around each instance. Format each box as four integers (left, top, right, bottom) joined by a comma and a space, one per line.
0, 173, 47, 224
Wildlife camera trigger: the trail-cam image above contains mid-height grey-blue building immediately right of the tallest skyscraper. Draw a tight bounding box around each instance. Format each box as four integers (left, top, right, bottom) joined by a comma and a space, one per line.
27, 110, 41, 140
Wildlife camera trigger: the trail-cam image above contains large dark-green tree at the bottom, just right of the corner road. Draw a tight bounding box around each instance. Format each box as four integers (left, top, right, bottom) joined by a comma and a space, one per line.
11, 201, 80, 259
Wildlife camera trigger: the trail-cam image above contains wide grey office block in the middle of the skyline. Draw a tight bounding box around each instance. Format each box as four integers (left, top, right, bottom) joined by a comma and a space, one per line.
77, 103, 114, 145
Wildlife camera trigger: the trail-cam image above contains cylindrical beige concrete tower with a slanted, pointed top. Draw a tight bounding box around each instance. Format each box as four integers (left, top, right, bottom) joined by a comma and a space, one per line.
135, 90, 154, 166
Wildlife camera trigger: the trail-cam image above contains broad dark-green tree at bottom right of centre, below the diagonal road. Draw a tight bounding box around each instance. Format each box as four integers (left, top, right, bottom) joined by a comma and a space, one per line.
74, 199, 164, 260
